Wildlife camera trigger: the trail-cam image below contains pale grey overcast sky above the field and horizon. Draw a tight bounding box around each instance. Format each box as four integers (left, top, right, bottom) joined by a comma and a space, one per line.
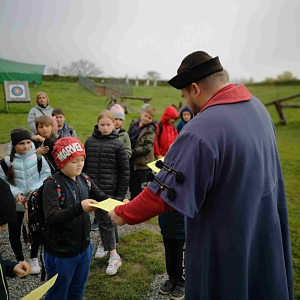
0, 0, 300, 81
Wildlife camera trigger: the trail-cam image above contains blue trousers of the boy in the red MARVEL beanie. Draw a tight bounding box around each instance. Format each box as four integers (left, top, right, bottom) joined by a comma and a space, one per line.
44, 244, 93, 300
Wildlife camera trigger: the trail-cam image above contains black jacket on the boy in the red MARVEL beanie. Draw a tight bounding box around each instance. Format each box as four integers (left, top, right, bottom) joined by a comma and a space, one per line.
43, 171, 107, 258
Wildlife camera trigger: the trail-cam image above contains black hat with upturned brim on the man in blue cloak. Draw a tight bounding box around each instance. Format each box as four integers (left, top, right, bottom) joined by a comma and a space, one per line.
168, 51, 223, 90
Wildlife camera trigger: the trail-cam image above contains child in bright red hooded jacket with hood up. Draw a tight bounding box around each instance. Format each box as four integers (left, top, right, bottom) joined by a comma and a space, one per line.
154, 106, 178, 159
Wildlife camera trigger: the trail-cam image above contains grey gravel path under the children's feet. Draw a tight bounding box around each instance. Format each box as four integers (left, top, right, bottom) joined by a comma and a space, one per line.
0, 212, 170, 300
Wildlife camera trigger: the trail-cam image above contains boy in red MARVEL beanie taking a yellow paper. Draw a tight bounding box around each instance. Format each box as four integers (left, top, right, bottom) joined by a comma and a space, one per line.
43, 137, 107, 300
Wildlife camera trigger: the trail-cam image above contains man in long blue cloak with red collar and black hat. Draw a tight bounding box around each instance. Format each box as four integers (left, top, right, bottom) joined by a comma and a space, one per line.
110, 51, 293, 300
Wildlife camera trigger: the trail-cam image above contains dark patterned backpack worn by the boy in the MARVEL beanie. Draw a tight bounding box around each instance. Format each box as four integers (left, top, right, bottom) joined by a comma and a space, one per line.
27, 173, 92, 281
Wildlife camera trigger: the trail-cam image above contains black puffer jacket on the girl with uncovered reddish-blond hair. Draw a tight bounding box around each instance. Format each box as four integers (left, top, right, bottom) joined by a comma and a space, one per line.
83, 125, 130, 199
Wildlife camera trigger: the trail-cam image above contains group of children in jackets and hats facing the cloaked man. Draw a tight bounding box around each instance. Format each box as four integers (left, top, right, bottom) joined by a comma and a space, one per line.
0, 92, 192, 299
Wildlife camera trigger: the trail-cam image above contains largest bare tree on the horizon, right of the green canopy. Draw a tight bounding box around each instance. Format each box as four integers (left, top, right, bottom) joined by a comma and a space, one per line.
61, 59, 103, 76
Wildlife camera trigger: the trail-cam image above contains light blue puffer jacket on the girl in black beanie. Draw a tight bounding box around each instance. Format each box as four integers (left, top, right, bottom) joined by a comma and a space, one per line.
0, 143, 51, 211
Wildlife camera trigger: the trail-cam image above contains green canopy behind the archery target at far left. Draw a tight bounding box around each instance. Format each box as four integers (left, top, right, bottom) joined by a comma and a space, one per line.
0, 58, 46, 84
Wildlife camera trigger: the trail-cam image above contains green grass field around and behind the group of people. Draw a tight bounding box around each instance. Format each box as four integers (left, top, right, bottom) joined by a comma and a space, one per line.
0, 82, 300, 299
